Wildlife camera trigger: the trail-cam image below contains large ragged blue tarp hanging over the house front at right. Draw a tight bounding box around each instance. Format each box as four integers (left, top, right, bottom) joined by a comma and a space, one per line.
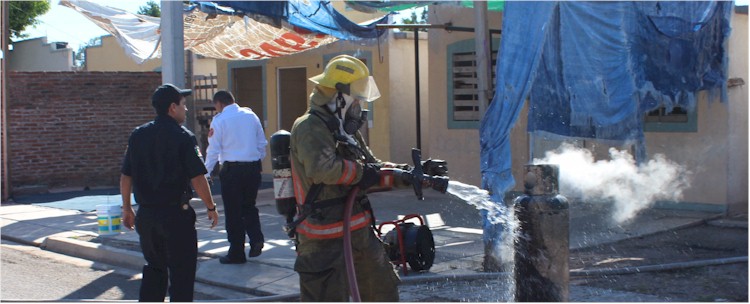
479, 1, 733, 209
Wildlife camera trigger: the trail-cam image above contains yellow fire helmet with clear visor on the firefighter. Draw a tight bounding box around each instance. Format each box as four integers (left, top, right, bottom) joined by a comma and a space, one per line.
310, 55, 380, 101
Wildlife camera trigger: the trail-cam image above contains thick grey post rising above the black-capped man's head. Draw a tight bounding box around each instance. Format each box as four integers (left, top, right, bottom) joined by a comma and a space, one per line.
161, 0, 185, 95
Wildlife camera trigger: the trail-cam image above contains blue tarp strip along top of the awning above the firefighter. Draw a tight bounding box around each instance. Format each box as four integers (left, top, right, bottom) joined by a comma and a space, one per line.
193, 0, 388, 40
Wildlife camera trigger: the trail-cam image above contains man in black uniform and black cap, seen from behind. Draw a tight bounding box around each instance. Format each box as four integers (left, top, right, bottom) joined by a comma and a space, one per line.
120, 84, 219, 302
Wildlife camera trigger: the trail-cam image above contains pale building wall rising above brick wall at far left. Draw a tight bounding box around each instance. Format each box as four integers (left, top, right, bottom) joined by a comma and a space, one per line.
6, 37, 73, 72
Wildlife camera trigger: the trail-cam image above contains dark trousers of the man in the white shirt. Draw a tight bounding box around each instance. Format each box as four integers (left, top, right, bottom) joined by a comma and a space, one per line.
219, 161, 265, 259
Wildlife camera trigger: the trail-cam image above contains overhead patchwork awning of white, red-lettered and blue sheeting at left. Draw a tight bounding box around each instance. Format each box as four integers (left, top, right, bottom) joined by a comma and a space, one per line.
60, 0, 387, 63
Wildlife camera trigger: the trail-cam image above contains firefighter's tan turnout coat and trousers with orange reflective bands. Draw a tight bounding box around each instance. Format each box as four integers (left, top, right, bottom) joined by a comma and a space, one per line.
290, 88, 399, 302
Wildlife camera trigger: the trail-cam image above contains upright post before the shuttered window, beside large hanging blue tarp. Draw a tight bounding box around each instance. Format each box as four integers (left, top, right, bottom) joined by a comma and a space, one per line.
474, 1, 492, 120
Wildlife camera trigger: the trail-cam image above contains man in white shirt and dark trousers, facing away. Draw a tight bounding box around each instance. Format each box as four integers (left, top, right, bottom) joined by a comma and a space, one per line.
206, 91, 268, 264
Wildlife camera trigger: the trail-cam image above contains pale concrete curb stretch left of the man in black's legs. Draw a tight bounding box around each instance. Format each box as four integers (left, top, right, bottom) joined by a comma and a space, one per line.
40, 237, 146, 270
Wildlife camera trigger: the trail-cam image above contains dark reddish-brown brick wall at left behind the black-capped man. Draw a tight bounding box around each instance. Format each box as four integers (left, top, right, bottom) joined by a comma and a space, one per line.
6, 72, 161, 189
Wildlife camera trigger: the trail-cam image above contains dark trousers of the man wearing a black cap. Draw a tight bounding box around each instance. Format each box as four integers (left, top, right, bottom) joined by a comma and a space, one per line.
135, 205, 198, 302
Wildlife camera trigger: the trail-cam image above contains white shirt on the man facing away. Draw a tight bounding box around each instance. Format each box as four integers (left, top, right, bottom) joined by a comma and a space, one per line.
206, 103, 268, 174
